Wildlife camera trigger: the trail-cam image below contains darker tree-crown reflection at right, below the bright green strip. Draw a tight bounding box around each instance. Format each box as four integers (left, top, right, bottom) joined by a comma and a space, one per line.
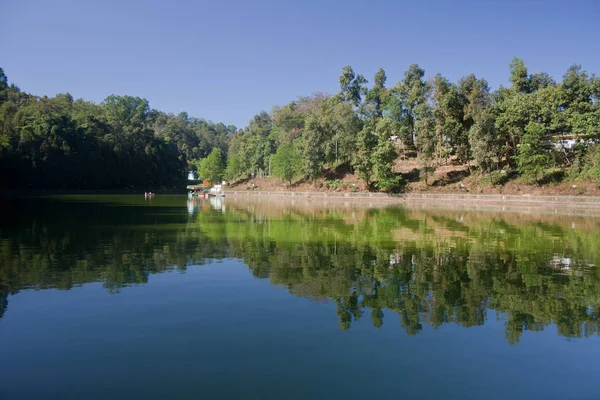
239, 238, 600, 342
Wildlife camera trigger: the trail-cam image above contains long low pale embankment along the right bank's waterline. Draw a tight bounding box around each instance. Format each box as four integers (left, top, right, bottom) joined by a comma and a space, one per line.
226, 190, 600, 215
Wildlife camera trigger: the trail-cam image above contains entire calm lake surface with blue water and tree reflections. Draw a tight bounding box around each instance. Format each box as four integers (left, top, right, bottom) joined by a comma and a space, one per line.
0, 195, 600, 400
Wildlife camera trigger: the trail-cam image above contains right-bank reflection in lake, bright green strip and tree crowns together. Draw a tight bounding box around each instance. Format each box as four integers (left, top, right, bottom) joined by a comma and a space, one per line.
219, 203, 600, 343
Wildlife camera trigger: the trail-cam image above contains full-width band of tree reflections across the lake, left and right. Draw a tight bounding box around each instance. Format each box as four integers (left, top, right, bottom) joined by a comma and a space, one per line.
0, 197, 600, 343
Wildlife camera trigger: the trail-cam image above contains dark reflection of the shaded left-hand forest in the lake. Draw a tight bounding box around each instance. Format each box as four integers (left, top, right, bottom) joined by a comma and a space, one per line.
0, 200, 227, 307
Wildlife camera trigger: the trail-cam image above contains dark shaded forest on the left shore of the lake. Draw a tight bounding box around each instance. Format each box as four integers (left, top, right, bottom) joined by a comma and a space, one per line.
0, 69, 235, 189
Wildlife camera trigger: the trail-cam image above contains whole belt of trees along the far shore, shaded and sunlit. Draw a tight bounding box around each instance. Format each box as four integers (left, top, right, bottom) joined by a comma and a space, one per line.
0, 58, 600, 191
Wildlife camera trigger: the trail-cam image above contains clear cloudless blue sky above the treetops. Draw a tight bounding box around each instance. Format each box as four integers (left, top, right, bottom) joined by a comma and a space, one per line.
0, 0, 600, 127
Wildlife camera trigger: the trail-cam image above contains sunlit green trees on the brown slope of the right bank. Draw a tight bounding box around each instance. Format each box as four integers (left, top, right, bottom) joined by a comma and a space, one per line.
227, 58, 600, 191
